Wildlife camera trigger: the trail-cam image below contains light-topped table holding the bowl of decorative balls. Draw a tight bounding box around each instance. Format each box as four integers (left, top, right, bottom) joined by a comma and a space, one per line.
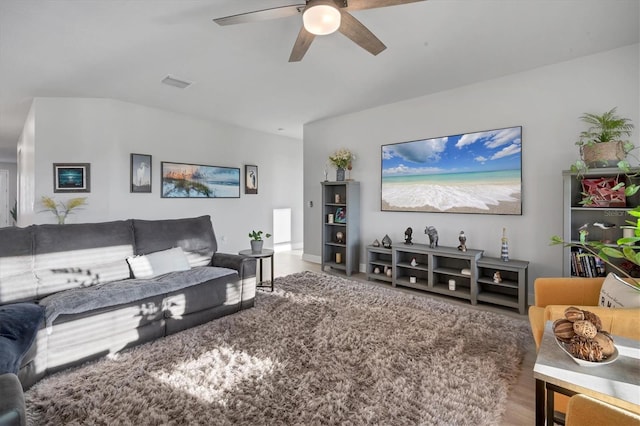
533, 321, 640, 426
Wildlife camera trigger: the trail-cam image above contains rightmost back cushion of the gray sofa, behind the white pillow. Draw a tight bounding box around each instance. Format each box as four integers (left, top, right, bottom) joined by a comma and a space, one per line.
133, 215, 218, 267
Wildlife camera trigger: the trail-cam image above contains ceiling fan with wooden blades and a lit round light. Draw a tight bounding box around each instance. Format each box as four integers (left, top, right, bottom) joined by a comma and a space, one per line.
213, 0, 425, 62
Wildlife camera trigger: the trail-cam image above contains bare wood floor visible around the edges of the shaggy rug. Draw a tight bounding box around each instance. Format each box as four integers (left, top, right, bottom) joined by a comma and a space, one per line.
265, 250, 536, 426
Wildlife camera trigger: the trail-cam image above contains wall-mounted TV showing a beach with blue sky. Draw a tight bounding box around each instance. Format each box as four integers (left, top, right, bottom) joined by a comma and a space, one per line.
381, 126, 522, 215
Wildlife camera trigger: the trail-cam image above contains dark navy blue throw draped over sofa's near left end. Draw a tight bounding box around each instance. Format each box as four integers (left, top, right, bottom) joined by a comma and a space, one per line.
0, 303, 44, 374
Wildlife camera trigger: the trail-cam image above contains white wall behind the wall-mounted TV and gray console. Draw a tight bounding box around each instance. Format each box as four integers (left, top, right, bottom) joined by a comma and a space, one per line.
304, 45, 640, 290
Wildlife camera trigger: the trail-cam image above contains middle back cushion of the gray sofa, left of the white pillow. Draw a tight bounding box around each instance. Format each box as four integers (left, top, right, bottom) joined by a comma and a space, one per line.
34, 220, 134, 297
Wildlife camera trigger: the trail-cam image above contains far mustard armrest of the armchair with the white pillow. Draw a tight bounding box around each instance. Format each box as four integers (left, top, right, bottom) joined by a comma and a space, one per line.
533, 277, 604, 308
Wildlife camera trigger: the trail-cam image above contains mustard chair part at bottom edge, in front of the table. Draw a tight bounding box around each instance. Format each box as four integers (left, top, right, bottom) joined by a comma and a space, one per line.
565, 394, 640, 426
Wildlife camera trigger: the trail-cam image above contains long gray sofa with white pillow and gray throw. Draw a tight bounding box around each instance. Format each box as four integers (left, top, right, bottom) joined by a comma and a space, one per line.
0, 216, 256, 424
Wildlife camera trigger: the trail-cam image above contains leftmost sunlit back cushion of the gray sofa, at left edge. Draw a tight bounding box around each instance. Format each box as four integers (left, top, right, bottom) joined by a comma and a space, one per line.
0, 226, 37, 304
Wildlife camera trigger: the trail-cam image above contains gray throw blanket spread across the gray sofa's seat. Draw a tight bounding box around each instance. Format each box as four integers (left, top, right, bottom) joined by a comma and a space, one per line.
40, 266, 237, 333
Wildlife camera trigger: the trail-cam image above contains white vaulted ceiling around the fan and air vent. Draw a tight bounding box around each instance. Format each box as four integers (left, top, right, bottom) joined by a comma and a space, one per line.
0, 0, 640, 161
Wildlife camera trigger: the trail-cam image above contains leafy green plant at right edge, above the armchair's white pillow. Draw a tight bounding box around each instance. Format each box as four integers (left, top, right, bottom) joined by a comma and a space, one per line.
551, 206, 640, 291
